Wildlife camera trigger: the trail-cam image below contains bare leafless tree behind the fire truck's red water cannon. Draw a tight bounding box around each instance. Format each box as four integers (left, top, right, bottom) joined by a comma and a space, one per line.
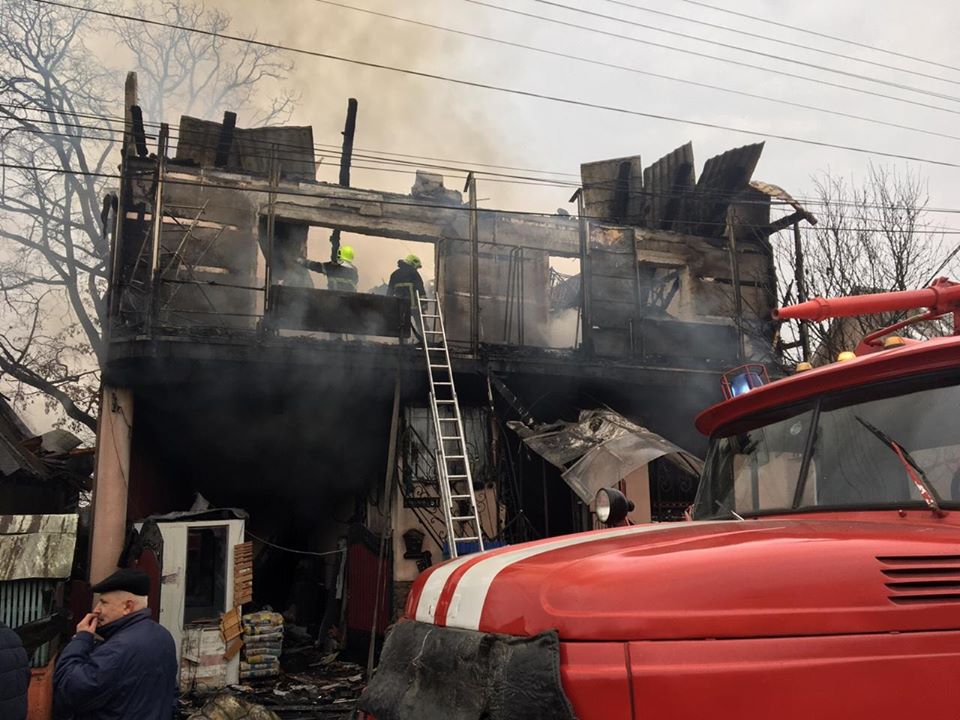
777, 165, 952, 361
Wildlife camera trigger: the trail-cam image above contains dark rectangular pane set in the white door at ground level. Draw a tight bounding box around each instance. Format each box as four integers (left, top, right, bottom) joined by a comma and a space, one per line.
183, 525, 227, 623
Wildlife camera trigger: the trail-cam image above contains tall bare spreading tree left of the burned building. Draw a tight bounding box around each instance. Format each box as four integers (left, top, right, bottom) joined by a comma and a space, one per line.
0, 0, 290, 430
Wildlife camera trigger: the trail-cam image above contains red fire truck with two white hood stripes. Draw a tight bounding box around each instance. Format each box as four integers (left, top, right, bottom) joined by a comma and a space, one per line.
361, 280, 960, 720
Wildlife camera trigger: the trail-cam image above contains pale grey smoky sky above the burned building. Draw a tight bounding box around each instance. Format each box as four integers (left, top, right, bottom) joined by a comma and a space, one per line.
186, 0, 960, 215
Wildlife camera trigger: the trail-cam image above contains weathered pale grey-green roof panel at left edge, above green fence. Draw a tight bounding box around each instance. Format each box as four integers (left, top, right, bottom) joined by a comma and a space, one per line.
0, 515, 77, 581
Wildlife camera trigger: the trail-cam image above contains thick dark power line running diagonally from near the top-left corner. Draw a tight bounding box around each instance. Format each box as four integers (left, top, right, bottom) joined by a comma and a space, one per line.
22, 0, 960, 168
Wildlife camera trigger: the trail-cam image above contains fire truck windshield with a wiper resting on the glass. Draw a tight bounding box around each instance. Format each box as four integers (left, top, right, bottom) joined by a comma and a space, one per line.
694, 377, 960, 519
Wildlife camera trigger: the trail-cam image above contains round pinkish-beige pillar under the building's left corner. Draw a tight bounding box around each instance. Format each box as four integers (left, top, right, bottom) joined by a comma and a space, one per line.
90, 385, 133, 583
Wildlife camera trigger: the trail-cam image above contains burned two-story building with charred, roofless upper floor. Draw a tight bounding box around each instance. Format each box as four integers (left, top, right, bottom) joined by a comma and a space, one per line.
91, 71, 808, 668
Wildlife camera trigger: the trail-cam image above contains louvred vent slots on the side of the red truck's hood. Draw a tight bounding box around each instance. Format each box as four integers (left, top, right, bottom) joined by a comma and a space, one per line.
877, 555, 960, 605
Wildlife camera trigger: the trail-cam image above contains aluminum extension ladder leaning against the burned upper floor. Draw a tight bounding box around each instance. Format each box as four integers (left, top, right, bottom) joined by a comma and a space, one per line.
417, 293, 483, 558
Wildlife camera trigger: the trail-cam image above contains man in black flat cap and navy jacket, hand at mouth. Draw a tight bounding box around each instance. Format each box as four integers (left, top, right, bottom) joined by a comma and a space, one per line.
53, 570, 177, 720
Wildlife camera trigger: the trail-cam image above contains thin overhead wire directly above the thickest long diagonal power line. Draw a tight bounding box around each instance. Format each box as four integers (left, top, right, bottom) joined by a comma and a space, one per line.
313, 0, 960, 145
